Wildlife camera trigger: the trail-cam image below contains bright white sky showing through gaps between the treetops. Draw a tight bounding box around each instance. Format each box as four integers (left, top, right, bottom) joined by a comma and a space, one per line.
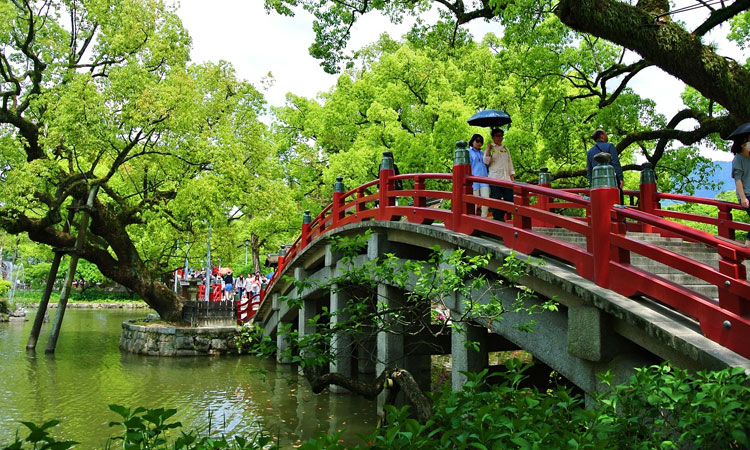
178, 0, 748, 160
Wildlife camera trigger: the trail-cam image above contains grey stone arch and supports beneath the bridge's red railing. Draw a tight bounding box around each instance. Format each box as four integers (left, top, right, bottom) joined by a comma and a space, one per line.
255, 221, 750, 414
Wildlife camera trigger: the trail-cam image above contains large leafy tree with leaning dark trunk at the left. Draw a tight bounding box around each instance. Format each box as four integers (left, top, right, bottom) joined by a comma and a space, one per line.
0, 0, 286, 320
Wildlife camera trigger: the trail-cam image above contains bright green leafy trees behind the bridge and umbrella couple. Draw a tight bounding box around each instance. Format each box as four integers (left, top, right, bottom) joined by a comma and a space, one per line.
276, 34, 713, 195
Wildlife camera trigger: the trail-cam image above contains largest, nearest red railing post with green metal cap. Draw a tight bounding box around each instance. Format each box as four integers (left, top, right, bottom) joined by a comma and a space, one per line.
590, 153, 620, 288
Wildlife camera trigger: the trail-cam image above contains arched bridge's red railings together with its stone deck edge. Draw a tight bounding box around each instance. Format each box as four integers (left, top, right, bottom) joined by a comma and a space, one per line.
251, 145, 750, 398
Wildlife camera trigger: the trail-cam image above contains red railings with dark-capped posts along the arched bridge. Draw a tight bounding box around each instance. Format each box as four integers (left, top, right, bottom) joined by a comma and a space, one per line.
261, 151, 750, 357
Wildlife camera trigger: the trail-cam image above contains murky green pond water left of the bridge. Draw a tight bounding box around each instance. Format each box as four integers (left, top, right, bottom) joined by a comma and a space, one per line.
0, 309, 376, 449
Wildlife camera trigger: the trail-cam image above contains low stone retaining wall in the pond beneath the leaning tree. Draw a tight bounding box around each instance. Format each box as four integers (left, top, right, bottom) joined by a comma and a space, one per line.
120, 320, 239, 356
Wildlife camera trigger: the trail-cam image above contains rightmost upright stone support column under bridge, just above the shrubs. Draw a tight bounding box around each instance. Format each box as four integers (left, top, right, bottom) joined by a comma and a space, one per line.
451, 324, 489, 391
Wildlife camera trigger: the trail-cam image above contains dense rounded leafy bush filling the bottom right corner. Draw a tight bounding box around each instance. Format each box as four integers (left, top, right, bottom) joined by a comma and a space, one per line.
597, 364, 750, 449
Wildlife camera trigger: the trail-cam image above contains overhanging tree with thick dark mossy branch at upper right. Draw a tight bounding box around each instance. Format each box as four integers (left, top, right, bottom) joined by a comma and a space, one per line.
266, 0, 750, 192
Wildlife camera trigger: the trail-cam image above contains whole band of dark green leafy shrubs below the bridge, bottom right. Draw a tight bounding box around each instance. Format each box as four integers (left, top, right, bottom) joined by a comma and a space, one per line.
348, 360, 750, 450
